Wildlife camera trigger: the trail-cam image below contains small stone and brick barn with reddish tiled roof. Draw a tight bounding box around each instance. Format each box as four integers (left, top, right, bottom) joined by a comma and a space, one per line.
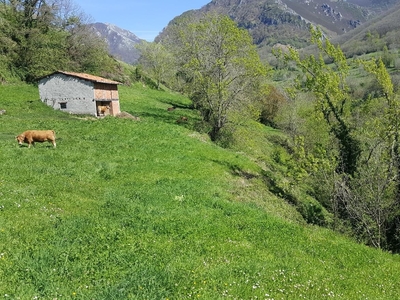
39, 71, 120, 117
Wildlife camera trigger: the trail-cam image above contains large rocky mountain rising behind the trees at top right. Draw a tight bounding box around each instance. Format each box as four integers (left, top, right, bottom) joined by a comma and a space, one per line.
156, 0, 399, 59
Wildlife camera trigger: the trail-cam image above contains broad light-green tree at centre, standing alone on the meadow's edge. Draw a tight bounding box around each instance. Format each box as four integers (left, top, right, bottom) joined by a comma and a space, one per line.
166, 14, 266, 140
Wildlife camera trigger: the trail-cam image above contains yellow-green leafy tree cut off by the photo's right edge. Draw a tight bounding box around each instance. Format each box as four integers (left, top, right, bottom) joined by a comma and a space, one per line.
359, 59, 400, 251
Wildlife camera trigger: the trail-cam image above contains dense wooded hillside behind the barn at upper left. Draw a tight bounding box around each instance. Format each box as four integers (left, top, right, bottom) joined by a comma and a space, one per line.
0, 0, 123, 82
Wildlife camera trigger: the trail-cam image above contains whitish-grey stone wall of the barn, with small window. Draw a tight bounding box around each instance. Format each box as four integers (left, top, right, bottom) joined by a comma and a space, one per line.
39, 74, 97, 115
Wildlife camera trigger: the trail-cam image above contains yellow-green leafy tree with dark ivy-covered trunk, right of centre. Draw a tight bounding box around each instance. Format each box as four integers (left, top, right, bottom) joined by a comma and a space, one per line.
285, 27, 361, 176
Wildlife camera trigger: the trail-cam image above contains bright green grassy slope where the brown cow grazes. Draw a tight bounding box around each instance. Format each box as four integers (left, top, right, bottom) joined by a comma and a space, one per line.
0, 85, 400, 299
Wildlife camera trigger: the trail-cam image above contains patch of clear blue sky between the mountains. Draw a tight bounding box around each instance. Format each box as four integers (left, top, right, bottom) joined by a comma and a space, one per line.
73, 0, 211, 42
